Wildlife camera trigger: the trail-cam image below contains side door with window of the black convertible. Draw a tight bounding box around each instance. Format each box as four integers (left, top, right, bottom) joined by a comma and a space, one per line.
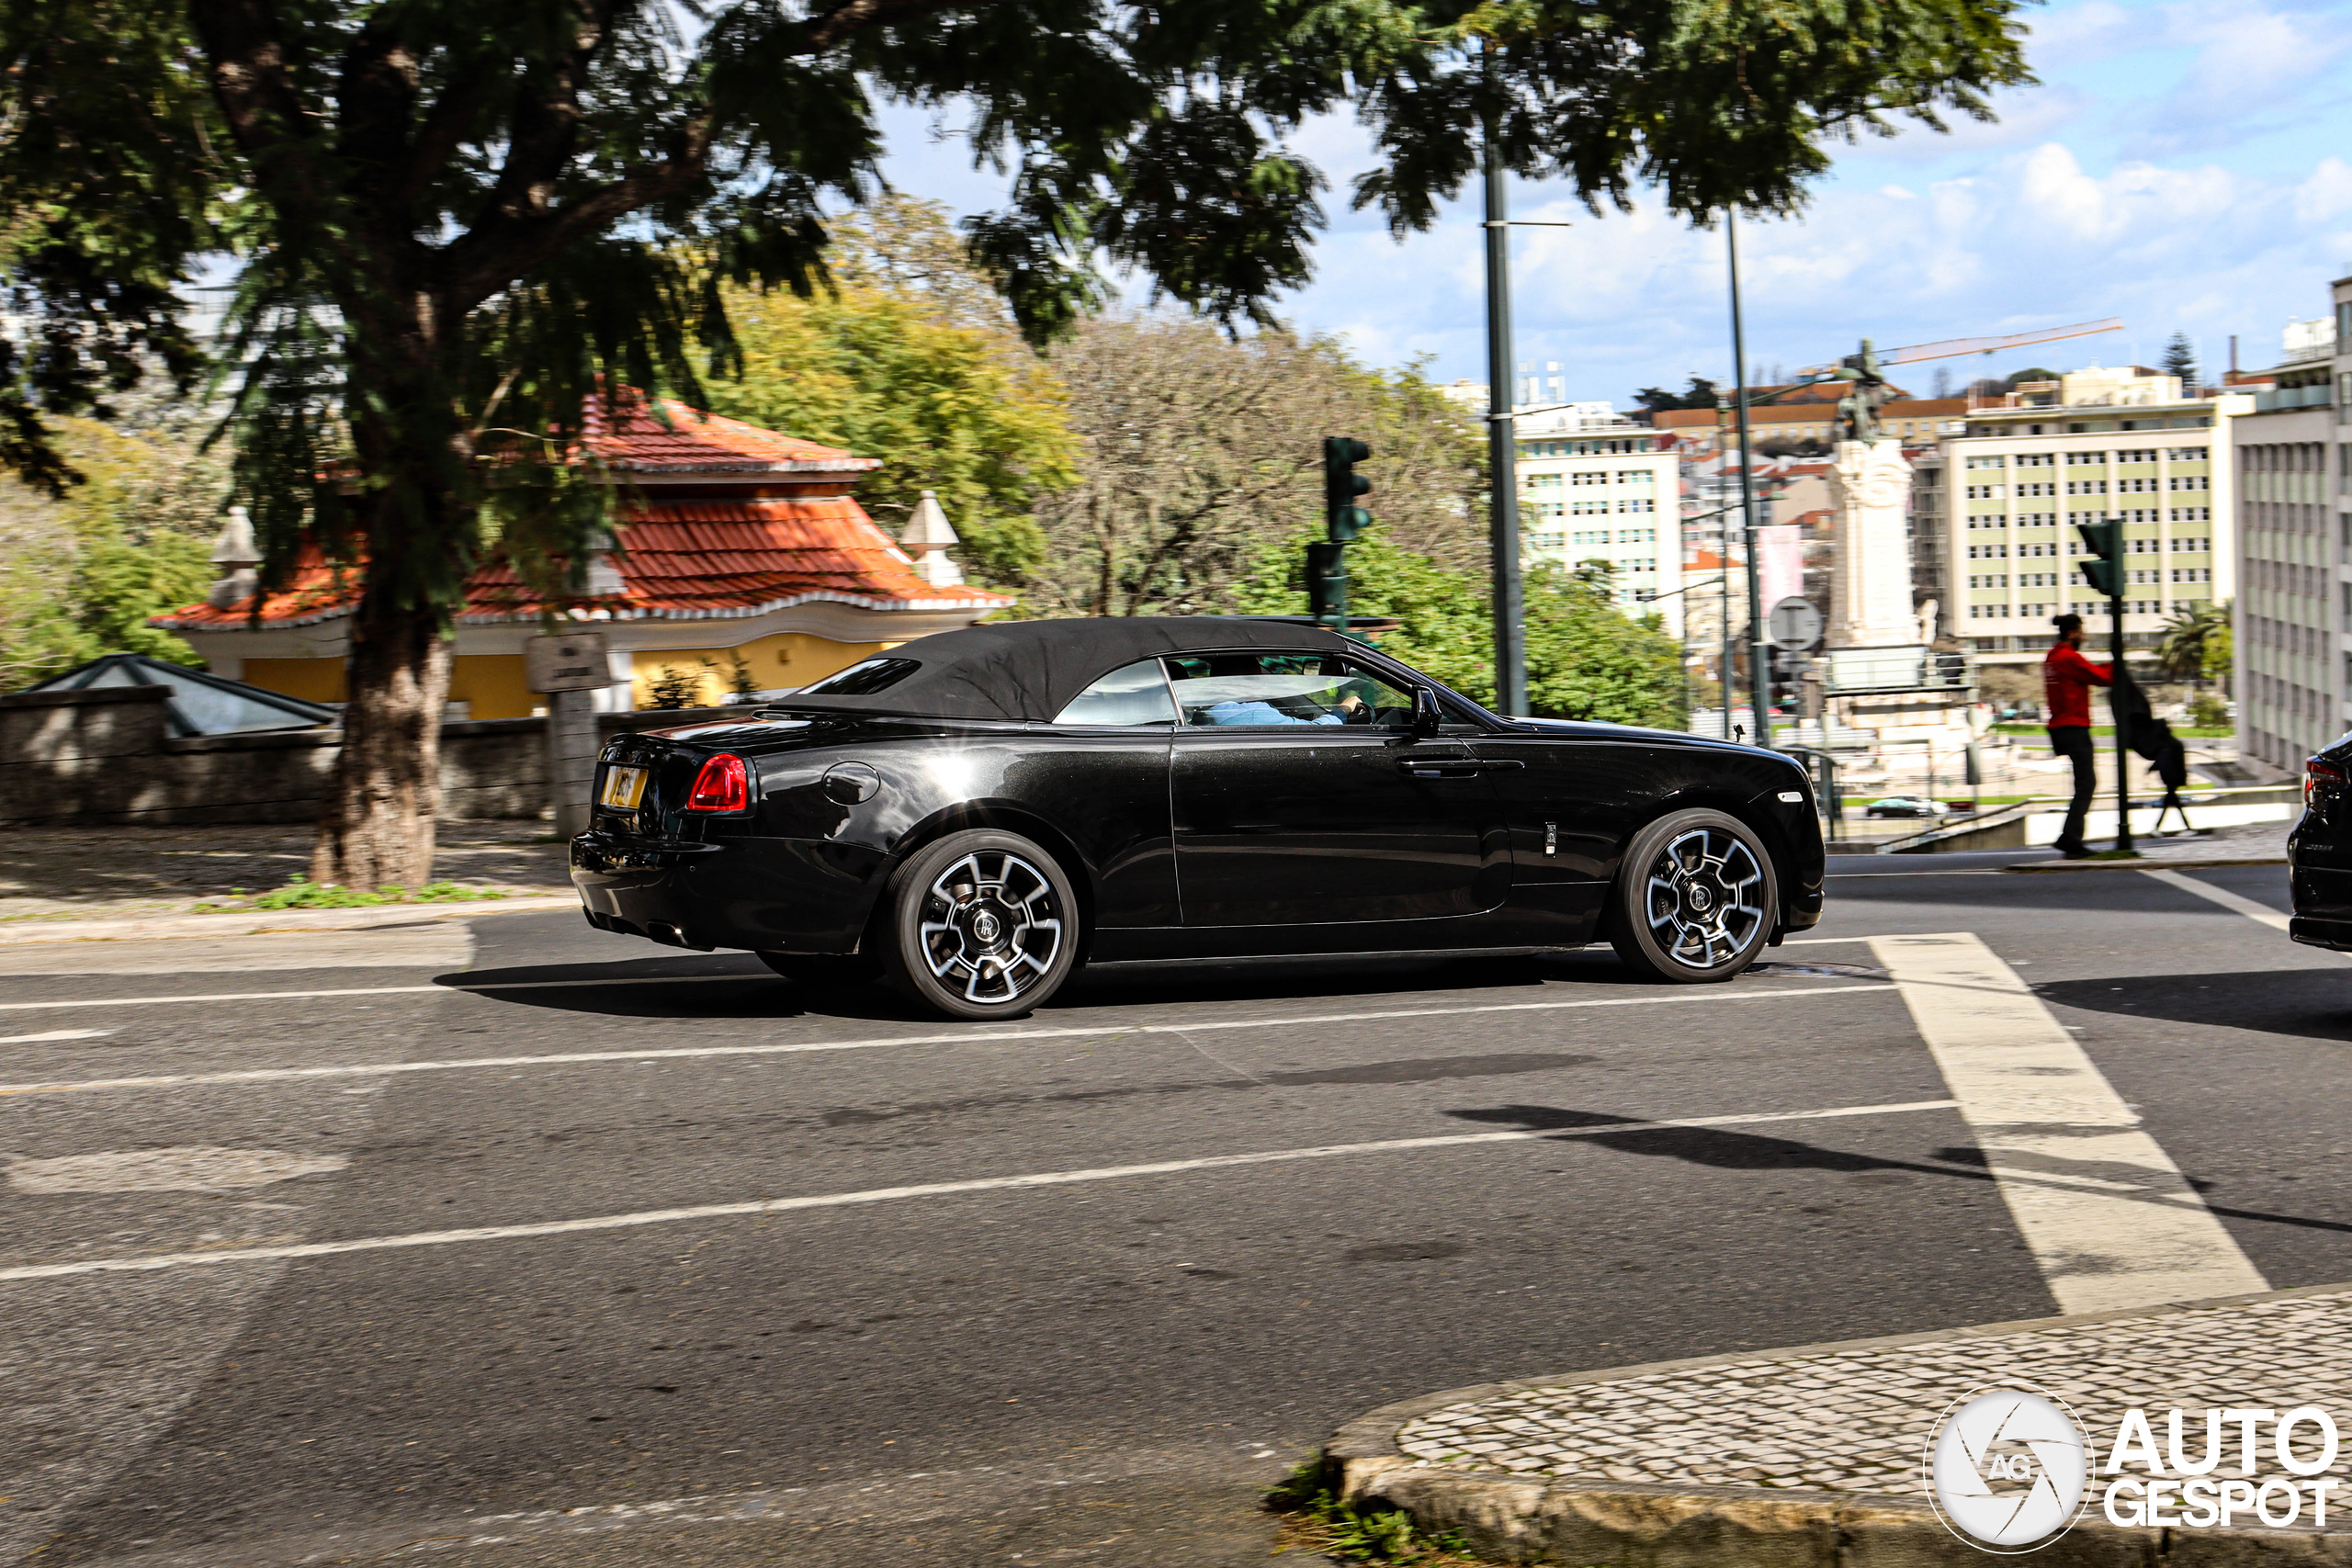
1164, 651, 1510, 926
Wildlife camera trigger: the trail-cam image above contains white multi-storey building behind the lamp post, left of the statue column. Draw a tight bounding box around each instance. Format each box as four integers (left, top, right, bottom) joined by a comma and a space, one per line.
1517, 402, 1684, 637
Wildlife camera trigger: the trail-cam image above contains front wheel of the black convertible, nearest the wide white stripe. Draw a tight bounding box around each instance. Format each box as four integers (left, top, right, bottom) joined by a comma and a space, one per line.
1609, 811, 1781, 985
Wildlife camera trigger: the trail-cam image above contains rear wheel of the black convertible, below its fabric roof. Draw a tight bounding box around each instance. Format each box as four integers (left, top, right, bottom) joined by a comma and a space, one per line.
877, 828, 1080, 1018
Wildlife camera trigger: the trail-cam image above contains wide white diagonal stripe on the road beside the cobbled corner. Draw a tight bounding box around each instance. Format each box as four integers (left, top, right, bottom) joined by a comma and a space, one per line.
1870, 931, 2269, 1312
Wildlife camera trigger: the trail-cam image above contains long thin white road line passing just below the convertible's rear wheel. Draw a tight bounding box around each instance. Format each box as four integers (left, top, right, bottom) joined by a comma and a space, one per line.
0, 983, 1886, 1096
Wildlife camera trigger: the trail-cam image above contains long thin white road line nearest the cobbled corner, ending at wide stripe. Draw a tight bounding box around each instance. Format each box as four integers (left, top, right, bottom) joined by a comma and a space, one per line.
0, 1100, 1952, 1281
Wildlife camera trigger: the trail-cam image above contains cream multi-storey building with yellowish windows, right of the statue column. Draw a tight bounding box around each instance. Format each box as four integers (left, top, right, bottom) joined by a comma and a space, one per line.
1940, 369, 2253, 665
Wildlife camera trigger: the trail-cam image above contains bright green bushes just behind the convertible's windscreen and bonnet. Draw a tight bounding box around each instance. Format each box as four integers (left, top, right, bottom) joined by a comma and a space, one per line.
1239, 529, 1689, 728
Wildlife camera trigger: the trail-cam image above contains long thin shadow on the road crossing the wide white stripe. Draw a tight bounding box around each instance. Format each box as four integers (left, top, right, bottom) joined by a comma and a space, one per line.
1446, 1105, 2352, 1235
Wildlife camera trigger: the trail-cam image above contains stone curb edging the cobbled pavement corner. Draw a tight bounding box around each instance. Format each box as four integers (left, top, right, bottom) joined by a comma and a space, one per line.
1324, 1283, 2352, 1568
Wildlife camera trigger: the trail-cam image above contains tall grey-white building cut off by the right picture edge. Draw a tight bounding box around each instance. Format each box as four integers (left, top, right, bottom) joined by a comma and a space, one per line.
2230, 277, 2352, 773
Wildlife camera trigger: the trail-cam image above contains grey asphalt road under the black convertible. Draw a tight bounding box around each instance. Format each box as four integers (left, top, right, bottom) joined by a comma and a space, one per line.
0, 856, 2352, 1568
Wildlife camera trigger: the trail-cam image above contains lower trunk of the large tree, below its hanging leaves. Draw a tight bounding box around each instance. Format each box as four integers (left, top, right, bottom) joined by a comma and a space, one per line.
311, 611, 449, 888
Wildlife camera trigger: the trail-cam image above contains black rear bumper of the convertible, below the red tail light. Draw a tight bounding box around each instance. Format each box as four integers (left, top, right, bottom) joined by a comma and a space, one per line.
571, 829, 882, 952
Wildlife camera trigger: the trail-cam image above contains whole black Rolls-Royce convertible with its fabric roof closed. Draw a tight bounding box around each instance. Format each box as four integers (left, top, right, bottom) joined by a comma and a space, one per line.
571, 616, 1823, 1018
